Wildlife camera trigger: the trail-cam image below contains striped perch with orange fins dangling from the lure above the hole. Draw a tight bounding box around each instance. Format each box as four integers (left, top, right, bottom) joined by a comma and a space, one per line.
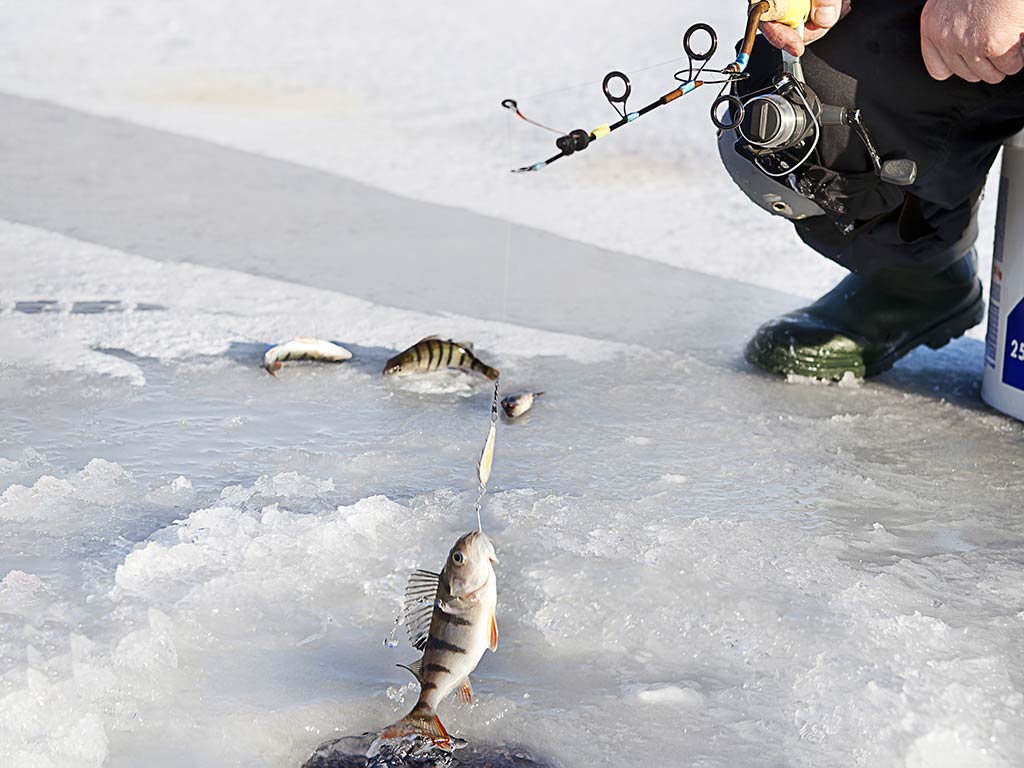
381, 530, 498, 749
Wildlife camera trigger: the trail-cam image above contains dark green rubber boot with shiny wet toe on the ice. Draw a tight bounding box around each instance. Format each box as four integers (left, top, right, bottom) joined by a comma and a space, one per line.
745, 249, 985, 381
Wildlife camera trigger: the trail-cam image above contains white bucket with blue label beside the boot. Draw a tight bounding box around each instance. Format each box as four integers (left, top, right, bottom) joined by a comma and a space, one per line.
981, 133, 1024, 421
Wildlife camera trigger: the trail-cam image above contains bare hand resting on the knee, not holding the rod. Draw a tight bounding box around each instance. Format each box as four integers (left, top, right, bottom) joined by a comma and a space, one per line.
921, 0, 1024, 83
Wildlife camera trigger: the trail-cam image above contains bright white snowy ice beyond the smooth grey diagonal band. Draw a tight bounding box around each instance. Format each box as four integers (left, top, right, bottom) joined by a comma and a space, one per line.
0, 0, 995, 307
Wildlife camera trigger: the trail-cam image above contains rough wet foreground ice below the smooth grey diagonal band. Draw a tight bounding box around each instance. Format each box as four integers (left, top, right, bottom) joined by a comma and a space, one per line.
0, 226, 1024, 768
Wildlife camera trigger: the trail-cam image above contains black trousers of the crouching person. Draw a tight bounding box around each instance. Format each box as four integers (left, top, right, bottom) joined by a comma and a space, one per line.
750, 0, 1024, 274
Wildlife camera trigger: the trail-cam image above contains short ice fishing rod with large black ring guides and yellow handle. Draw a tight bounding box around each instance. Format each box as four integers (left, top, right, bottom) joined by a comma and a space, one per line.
502, 0, 810, 173
